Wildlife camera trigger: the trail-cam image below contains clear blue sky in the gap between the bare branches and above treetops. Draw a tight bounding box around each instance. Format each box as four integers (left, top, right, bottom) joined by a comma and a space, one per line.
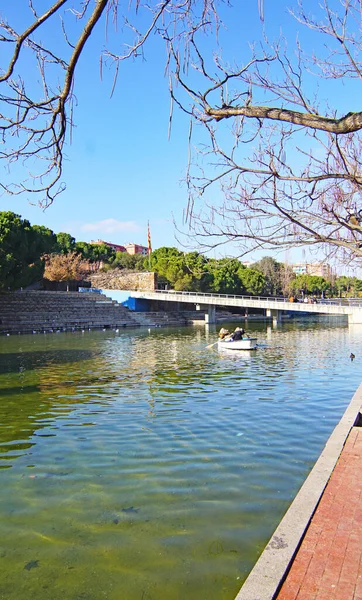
0, 0, 353, 272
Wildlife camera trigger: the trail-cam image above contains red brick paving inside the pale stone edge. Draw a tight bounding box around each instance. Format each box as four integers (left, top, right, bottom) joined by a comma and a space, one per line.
277, 427, 362, 600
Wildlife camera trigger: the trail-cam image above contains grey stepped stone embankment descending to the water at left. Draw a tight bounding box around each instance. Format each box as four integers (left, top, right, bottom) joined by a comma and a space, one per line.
0, 291, 191, 334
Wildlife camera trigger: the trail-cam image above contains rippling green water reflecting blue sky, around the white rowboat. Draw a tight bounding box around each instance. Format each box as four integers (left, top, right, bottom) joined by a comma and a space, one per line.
0, 321, 362, 600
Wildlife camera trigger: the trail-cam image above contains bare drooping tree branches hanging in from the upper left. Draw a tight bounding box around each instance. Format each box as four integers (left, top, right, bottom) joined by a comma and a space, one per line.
0, 0, 222, 207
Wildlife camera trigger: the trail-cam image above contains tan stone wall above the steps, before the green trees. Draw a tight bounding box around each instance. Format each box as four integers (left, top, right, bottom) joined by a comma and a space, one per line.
88, 269, 157, 292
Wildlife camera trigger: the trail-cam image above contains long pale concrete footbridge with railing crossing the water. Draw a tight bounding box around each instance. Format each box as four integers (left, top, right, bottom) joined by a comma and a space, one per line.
129, 290, 362, 323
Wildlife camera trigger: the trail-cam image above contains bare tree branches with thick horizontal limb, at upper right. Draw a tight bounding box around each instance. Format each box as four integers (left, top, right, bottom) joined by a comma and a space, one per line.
169, 0, 362, 261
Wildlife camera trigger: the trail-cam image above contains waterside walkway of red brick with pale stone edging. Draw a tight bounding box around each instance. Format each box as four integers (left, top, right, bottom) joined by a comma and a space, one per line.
236, 385, 362, 600
